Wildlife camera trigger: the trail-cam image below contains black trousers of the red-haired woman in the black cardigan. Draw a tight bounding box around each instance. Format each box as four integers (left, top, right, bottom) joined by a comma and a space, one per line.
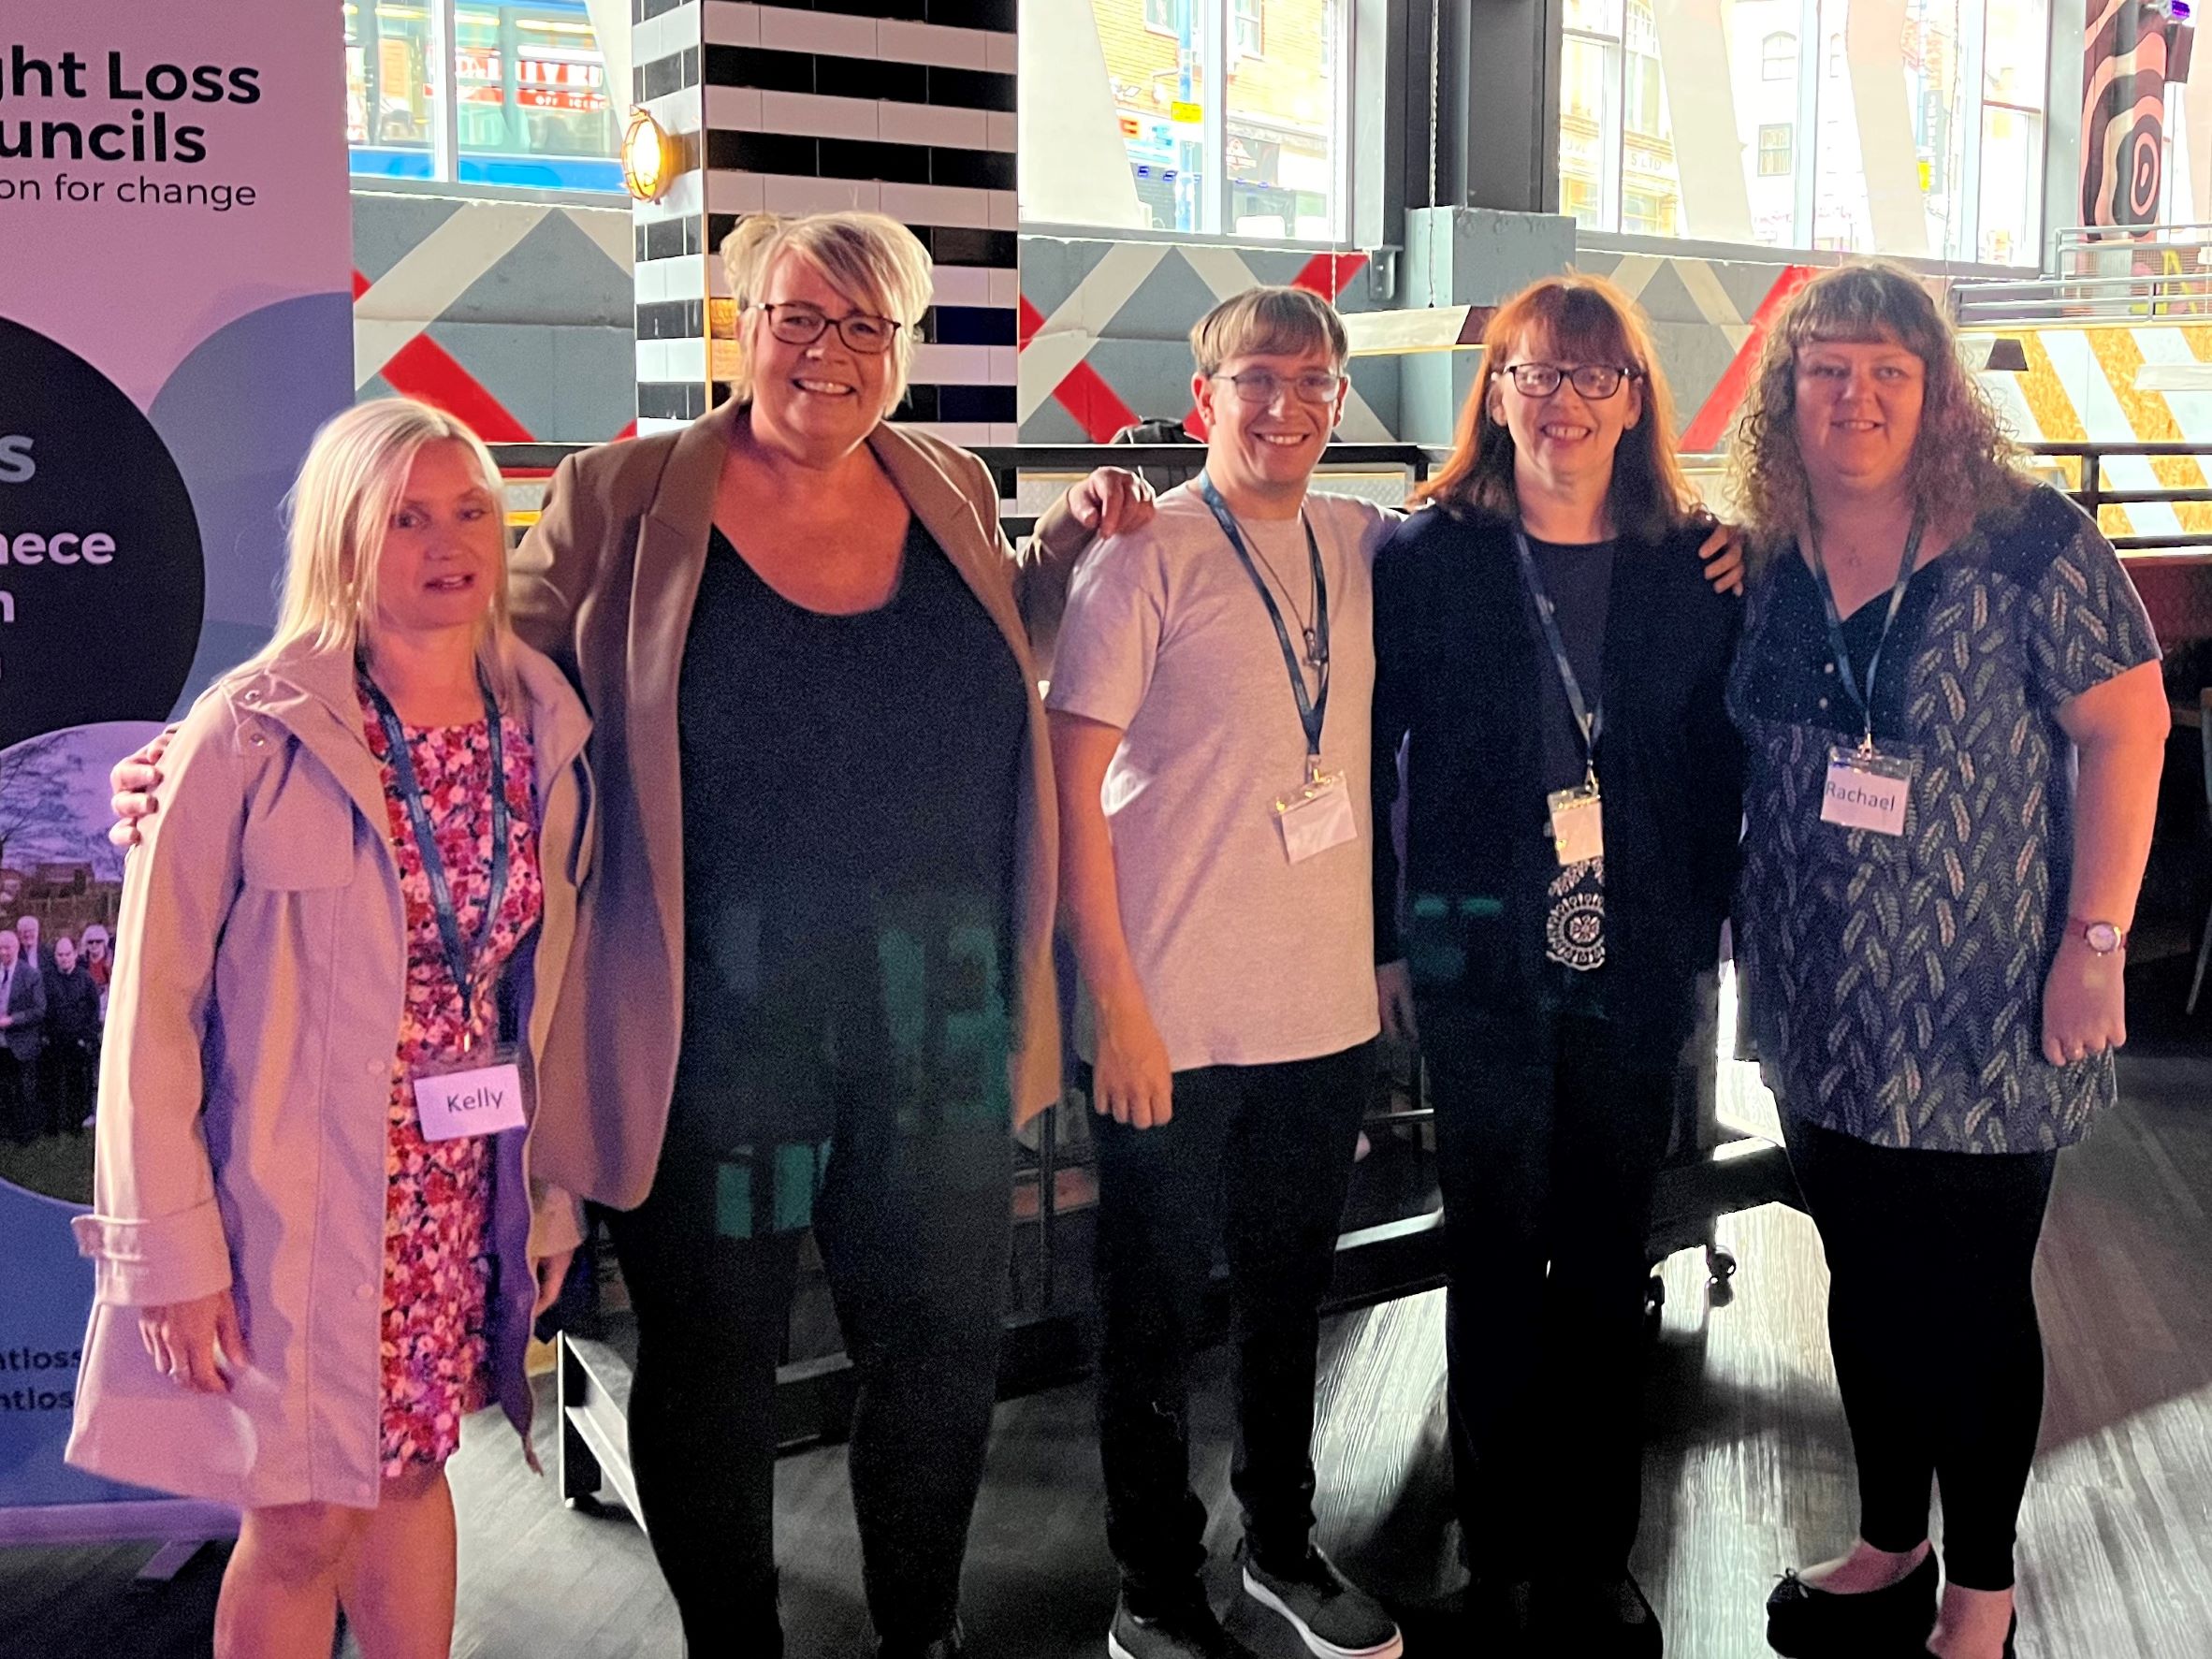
1420, 968, 1677, 1579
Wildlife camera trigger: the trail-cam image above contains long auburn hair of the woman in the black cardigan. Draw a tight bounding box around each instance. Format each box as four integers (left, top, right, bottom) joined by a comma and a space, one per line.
1414, 272, 1699, 542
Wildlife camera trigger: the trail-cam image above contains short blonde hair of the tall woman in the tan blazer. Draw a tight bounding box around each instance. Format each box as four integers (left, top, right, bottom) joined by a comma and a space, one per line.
721, 211, 936, 414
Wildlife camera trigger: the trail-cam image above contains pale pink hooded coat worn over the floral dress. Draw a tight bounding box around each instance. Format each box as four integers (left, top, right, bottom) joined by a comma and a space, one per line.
66, 648, 590, 1508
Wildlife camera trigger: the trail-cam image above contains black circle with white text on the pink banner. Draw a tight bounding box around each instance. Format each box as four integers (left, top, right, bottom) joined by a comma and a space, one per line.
0, 318, 206, 748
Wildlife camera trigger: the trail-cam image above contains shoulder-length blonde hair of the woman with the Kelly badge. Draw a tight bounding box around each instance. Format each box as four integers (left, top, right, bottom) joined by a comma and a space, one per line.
250, 399, 516, 704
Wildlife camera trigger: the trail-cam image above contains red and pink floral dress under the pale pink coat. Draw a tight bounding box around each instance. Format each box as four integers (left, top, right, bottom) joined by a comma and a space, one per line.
360, 691, 545, 1477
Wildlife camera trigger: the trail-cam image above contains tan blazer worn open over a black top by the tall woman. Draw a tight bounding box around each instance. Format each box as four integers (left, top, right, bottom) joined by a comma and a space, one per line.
513, 402, 1059, 1210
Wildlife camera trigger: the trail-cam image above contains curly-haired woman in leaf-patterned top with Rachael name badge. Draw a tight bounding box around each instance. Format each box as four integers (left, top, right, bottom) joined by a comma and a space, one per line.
1730, 263, 2168, 1659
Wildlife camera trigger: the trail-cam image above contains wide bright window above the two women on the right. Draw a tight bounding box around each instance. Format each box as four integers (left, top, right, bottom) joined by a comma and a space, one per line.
1560, 0, 2050, 266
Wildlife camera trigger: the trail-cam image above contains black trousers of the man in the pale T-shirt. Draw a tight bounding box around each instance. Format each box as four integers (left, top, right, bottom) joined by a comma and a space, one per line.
1084, 1041, 1374, 1610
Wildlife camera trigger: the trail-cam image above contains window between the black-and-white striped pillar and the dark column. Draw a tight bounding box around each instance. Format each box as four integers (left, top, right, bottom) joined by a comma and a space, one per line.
1020, 0, 1351, 241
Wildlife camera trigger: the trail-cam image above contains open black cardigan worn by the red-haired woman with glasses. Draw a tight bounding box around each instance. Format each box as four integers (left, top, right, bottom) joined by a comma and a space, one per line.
1374, 506, 1743, 1057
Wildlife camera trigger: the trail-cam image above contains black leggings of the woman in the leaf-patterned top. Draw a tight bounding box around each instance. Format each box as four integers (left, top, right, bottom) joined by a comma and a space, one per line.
1783, 1113, 2058, 1591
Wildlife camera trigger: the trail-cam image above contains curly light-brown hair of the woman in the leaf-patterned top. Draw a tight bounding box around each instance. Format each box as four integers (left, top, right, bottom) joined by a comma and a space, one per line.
1727, 259, 2033, 555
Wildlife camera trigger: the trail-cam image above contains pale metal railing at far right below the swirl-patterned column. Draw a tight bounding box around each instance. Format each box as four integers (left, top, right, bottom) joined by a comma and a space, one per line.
1951, 224, 2212, 327
